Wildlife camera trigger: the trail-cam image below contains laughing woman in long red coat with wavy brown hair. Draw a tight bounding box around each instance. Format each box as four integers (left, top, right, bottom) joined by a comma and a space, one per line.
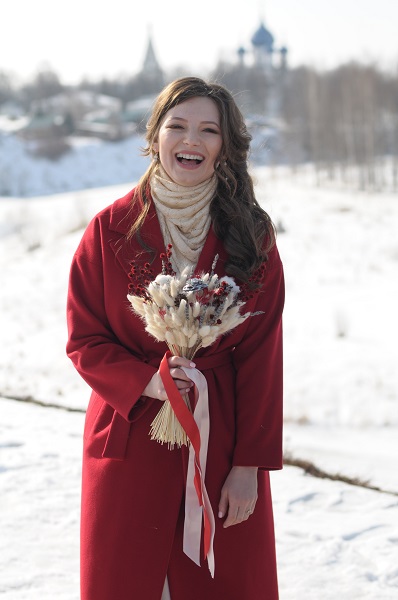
67, 77, 284, 600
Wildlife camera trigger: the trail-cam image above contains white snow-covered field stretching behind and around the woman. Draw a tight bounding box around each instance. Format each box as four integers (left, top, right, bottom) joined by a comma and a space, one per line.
0, 140, 398, 600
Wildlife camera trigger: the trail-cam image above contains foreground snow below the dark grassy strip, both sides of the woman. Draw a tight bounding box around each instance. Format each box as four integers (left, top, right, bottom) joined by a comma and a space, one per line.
0, 400, 398, 600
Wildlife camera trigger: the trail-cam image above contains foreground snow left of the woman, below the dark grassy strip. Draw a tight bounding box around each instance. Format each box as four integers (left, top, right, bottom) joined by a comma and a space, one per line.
0, 400, 84, 600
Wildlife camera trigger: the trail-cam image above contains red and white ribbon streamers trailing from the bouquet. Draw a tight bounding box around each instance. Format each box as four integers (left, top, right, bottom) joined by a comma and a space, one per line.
159, 351, 215, 577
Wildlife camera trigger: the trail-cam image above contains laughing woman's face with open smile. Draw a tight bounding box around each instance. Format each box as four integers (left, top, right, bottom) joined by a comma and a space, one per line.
153, 97, 222, 186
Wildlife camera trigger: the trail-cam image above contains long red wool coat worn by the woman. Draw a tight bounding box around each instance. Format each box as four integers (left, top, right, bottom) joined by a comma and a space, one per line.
67, 192, 284, 600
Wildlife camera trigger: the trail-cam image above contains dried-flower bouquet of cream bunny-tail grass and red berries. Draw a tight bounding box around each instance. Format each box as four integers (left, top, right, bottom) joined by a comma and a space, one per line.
127, 245, 264, 448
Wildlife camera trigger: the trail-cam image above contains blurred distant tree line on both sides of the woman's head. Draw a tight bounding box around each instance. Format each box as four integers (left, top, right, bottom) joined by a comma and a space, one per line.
0, 62, 398, 190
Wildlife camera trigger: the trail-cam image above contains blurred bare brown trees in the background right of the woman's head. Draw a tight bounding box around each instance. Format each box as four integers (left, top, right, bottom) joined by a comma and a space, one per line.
213, 62, 398, 190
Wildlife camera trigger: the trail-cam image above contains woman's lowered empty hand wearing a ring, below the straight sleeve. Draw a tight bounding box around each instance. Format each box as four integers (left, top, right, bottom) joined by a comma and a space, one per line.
218, 467, 258, 527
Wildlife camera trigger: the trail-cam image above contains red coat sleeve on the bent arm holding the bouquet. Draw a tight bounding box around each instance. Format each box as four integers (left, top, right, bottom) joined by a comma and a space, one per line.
66, 219, 156, 421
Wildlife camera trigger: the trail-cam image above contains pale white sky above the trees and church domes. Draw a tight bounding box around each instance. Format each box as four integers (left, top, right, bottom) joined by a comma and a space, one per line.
0, 0, 398, 83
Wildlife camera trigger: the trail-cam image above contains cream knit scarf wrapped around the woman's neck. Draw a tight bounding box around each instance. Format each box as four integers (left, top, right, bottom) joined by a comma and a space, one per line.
150, 165, 217, 274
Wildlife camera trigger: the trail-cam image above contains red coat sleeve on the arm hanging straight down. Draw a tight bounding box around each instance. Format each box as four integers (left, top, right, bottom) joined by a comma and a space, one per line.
233, 247, 285, 470
